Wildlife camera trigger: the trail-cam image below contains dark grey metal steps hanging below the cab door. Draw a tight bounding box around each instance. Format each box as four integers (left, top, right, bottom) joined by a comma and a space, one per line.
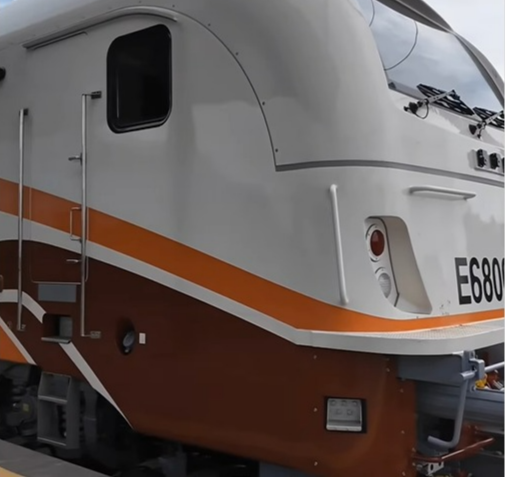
37, 372, 81, 450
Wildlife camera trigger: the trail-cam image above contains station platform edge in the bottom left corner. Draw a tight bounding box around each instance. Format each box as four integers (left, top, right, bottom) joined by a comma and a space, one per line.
0, 440, 106, 477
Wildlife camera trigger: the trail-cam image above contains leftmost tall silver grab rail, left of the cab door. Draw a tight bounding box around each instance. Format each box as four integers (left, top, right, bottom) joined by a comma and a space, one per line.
16, 108, 28, 331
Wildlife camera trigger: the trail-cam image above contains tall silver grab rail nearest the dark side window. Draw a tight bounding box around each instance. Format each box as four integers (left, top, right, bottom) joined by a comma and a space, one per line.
68, 91, 102, 339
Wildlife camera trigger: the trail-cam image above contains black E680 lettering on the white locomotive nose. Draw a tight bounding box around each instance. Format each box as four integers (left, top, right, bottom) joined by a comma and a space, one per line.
455, 257, 505, 305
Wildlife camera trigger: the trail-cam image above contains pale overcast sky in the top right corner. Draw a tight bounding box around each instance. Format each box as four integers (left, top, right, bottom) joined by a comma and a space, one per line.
425, 0, 505, 78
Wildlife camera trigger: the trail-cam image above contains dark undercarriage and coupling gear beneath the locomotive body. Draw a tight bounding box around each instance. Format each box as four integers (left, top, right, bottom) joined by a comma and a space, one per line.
0, 345, 504, 477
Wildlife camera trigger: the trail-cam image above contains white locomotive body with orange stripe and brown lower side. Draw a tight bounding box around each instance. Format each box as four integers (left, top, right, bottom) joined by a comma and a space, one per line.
0, 0, 505, 477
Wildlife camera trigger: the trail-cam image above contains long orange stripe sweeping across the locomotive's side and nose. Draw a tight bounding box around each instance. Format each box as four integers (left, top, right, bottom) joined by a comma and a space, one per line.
0, 179, 503, 332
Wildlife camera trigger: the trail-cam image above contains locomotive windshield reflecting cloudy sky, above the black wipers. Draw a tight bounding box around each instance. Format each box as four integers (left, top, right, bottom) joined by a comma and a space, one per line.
356, 0, 503, 111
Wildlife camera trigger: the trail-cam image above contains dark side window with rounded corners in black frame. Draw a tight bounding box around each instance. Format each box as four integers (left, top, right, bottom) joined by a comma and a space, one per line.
107, 25, 171, 132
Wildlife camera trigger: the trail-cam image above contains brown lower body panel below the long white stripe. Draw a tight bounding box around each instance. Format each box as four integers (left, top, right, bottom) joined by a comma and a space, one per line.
0, 242, 416, 477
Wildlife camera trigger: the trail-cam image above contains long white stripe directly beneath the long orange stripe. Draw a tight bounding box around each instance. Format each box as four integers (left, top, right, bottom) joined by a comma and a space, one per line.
0, 212, 504, 355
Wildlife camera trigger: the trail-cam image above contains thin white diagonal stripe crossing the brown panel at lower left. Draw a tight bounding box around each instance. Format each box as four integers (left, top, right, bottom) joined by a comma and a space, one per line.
0, 290, 129, 424
